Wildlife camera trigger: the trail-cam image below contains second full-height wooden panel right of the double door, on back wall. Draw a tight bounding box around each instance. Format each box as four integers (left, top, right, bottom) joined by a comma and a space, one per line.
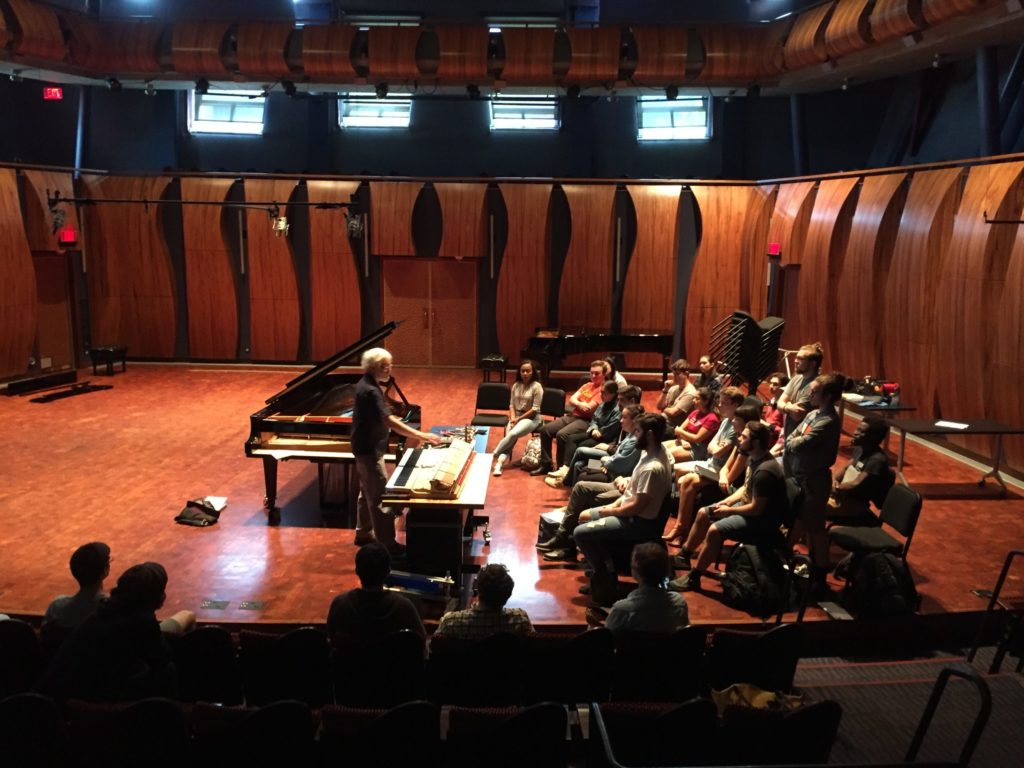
558, 184, 615, 346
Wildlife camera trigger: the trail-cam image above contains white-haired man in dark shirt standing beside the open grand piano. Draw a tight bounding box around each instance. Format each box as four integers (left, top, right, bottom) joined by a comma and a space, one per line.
352, 347, 440, 557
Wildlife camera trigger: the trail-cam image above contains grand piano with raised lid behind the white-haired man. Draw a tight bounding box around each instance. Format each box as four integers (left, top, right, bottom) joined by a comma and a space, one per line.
246, 322, 420, 525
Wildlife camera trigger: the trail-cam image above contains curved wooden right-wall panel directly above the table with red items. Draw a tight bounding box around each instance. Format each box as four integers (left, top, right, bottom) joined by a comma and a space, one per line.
828, 173, 906, 377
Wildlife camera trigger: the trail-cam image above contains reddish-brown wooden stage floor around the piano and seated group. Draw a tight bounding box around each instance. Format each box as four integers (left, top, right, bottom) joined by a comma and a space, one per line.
0, 364, 1024, 626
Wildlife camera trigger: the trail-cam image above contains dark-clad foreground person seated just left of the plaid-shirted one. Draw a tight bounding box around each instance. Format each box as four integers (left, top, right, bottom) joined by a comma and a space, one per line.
327, 543, 427, 643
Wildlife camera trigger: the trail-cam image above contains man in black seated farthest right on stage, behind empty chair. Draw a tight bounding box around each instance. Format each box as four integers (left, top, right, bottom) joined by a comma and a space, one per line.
825, 419, 896, 524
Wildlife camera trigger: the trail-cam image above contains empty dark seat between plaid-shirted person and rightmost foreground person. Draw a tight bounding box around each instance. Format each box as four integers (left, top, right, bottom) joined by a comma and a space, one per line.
522, 627, 615, 705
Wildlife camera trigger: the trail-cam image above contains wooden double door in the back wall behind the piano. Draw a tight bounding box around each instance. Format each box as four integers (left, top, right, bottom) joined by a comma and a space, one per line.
383, 258, 477, 368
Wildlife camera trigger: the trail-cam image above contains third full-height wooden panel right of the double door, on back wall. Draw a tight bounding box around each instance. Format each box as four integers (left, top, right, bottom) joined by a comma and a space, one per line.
623, 184, 683, 369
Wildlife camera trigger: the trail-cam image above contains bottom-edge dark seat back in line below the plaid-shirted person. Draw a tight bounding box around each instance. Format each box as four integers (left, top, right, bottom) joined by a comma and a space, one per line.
444, 701, 568, 768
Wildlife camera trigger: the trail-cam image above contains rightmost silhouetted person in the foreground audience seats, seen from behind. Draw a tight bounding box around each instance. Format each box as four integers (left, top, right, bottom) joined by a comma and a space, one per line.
604, 542, 690, 635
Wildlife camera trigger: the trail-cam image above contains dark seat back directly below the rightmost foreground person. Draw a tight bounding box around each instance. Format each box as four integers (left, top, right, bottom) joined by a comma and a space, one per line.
611, 627, 708, 701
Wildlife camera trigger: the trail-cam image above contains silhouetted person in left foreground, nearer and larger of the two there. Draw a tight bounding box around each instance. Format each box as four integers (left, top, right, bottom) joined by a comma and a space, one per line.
35, 562, 177, 701
